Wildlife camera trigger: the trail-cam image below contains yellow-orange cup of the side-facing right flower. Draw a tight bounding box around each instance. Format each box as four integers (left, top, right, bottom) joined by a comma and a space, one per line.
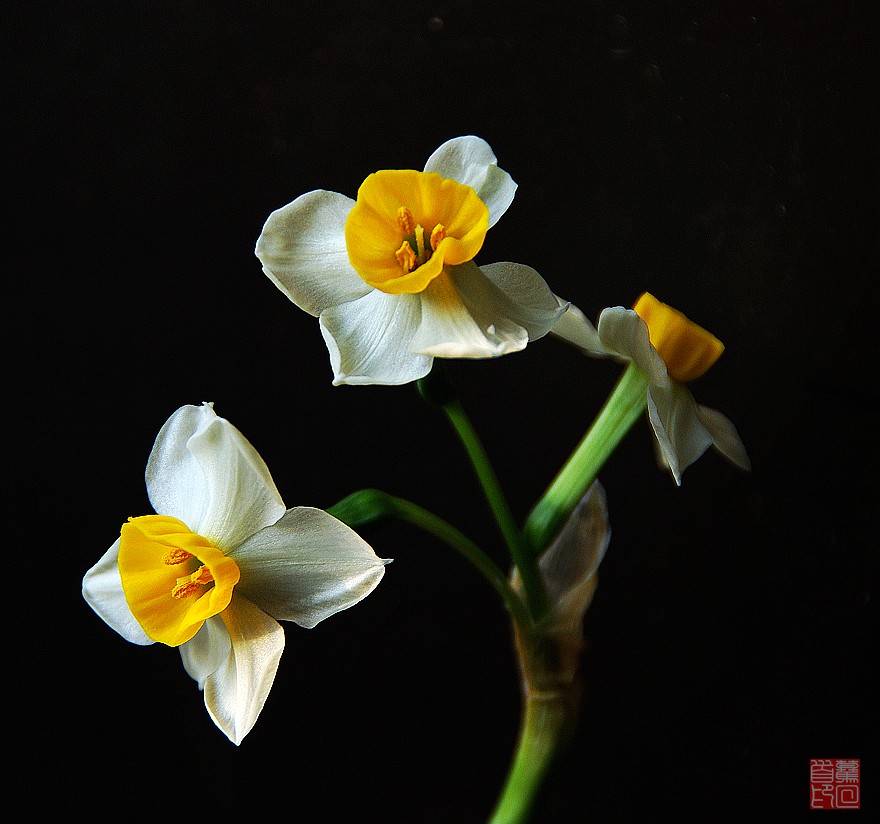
633, 292, 724, 383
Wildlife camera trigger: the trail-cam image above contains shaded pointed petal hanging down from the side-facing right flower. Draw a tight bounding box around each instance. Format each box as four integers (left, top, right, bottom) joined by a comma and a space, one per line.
648, 381, 712, 486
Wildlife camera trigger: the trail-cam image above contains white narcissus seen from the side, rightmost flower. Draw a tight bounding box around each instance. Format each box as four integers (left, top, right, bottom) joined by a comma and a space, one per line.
553, 292, 751, 485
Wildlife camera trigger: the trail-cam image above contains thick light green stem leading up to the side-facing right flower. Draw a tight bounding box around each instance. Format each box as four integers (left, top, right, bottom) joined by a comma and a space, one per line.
524, 363, 648, 553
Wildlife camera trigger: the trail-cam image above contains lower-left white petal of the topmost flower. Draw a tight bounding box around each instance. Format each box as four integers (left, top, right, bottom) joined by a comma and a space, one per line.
321, 289, 433, 386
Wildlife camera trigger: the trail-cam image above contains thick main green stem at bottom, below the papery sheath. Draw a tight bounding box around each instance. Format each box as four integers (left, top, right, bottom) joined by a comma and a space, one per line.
489, 693, 570, 824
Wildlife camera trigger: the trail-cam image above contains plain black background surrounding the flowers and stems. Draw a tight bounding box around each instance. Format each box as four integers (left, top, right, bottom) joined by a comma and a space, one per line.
8, 0, 880, 824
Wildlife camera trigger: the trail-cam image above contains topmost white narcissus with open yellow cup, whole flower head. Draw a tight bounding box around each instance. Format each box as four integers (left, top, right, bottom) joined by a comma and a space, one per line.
256, 136, 565, 385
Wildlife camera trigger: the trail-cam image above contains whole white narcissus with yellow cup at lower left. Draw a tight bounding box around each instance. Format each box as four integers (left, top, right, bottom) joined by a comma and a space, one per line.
83, 404, 388, 744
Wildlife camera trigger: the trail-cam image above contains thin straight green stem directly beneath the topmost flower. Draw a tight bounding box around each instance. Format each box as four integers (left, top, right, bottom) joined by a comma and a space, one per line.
441, 399, 549, 621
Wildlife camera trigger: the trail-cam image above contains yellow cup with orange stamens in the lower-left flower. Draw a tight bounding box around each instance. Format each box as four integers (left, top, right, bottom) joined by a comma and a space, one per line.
119, 515, 239, 647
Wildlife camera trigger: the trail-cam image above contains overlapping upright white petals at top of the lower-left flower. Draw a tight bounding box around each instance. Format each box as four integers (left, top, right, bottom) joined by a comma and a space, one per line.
147, 404, 285, 551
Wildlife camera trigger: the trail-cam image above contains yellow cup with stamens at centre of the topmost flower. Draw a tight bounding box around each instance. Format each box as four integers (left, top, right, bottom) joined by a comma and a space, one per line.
345, 169, 489, 295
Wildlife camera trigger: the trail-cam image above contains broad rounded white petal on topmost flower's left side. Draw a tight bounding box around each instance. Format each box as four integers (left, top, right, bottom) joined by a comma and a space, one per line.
255, 190, 370, 317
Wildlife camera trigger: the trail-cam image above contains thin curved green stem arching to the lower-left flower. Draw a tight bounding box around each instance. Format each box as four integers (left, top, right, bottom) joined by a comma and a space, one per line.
327, 489, 533, 638
